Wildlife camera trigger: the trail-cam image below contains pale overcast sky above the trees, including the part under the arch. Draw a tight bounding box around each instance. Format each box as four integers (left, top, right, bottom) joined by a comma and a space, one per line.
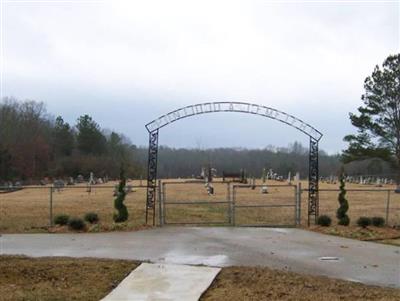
1, 0, 400, 153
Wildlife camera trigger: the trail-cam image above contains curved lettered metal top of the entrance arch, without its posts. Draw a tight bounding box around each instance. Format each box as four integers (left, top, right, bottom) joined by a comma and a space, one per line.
146, 102, 322, 141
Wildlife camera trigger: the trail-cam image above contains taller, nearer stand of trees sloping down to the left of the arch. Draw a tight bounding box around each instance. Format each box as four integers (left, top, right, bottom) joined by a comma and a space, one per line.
0, 98, 142, 182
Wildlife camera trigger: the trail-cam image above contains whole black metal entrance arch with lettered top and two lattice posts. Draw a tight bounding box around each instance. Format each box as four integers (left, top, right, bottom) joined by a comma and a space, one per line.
146, 102, 322, 225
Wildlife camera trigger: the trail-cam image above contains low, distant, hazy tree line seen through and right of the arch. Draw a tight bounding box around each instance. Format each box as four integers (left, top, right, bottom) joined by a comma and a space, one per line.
131, 142, 392, 178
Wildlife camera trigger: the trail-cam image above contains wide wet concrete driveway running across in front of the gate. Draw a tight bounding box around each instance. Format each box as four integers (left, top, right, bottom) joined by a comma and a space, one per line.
0, 227, 400, 288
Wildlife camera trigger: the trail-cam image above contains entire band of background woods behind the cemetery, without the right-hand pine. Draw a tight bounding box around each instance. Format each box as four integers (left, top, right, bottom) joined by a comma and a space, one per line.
0, 98, 391, 183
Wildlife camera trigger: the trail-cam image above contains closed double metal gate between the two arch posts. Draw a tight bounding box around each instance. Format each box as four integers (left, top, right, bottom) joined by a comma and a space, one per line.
158, 181, 301, 227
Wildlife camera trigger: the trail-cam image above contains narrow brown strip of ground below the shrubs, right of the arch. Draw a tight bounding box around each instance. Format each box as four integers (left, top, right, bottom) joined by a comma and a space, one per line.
307, 225, 400, 245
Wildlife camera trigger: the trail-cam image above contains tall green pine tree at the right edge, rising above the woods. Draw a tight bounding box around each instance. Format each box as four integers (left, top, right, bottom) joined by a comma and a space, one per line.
342, 53, 400, 186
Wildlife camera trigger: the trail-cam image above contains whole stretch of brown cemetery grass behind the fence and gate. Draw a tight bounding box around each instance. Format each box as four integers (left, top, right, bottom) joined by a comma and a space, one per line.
0, 180, 400, 233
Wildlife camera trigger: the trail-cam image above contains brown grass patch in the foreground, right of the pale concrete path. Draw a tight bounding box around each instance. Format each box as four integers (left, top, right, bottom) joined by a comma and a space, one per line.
201, 267, 400, 301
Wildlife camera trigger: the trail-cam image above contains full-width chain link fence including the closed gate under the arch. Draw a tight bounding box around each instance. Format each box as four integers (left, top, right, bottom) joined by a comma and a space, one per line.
0, 181, 400, 233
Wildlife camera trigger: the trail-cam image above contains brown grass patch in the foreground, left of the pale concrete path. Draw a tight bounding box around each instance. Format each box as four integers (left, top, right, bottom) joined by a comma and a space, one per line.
0, 256, 139, 301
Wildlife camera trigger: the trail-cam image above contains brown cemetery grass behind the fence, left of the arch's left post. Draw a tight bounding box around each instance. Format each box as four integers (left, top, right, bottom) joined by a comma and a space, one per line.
0, 180, 146, 233
